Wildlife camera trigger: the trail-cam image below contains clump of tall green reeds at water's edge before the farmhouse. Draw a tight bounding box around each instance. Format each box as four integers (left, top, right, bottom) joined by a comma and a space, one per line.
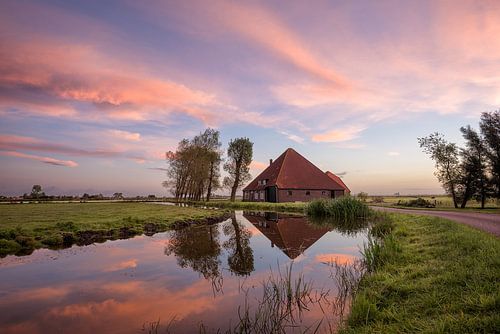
306, 196, 372, 221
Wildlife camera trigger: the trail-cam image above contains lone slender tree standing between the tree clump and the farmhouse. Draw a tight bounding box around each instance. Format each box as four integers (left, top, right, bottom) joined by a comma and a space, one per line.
224, 138, 253, 202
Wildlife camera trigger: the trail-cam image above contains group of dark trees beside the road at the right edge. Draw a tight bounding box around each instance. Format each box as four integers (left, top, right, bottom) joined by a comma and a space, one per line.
418, 110, 500, 208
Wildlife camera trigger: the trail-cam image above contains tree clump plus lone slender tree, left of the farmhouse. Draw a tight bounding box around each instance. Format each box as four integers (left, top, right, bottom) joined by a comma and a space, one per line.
163, 128, 253, 201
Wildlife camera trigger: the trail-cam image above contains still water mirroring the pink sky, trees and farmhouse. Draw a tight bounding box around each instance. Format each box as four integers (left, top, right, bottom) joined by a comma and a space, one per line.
0, 212, 366, 333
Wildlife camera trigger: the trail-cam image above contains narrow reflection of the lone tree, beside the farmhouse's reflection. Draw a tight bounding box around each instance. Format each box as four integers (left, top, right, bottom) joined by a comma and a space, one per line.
223, 217, 254, 276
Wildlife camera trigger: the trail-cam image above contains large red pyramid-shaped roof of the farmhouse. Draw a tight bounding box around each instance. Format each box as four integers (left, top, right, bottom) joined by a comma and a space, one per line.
243, 148, 344, 190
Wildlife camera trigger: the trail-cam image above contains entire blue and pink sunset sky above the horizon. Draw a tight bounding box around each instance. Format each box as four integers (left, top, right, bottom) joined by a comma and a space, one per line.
0, 0, 500, 196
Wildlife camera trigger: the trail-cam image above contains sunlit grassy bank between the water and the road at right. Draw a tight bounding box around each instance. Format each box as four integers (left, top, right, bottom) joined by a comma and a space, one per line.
343, 214, 500, 333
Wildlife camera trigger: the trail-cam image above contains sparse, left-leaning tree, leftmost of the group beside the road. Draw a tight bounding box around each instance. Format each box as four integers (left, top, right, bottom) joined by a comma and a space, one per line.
418, 132, 461, 208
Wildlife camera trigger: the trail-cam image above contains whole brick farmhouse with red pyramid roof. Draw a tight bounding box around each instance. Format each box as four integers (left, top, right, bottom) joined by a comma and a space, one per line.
243, 148, 350, 202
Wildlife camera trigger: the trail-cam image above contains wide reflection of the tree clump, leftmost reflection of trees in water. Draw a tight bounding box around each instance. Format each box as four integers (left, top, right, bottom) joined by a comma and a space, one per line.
165, 225, 222, 281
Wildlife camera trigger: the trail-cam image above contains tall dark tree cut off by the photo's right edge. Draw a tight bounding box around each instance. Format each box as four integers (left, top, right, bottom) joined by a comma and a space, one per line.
479, 110, 500, 199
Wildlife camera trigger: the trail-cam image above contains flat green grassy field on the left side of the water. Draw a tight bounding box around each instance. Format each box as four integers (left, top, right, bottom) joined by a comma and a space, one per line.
0, 203, 227, 256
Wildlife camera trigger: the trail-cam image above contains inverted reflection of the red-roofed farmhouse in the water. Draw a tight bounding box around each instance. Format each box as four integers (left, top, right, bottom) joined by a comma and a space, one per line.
243, 212, 330, 260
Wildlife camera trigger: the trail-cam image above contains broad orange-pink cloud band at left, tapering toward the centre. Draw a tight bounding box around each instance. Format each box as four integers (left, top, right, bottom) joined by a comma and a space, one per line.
0, 37, 250, 125
